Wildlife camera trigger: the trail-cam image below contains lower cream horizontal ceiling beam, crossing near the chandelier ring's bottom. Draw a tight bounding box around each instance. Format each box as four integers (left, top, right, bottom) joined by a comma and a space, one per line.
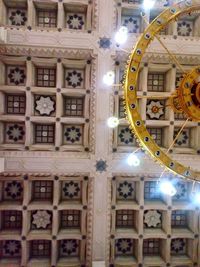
0, 152, 199, 176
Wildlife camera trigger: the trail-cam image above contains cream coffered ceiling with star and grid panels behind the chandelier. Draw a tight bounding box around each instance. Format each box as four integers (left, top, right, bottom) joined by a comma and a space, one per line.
0, 0, 200, 267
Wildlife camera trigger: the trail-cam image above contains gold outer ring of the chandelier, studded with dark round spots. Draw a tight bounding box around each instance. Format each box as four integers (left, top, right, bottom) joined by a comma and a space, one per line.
123, 0, 200, 181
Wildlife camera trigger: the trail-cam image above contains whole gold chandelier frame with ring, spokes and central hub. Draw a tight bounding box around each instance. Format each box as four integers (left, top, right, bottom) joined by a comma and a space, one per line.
123, 0, 200, 181
